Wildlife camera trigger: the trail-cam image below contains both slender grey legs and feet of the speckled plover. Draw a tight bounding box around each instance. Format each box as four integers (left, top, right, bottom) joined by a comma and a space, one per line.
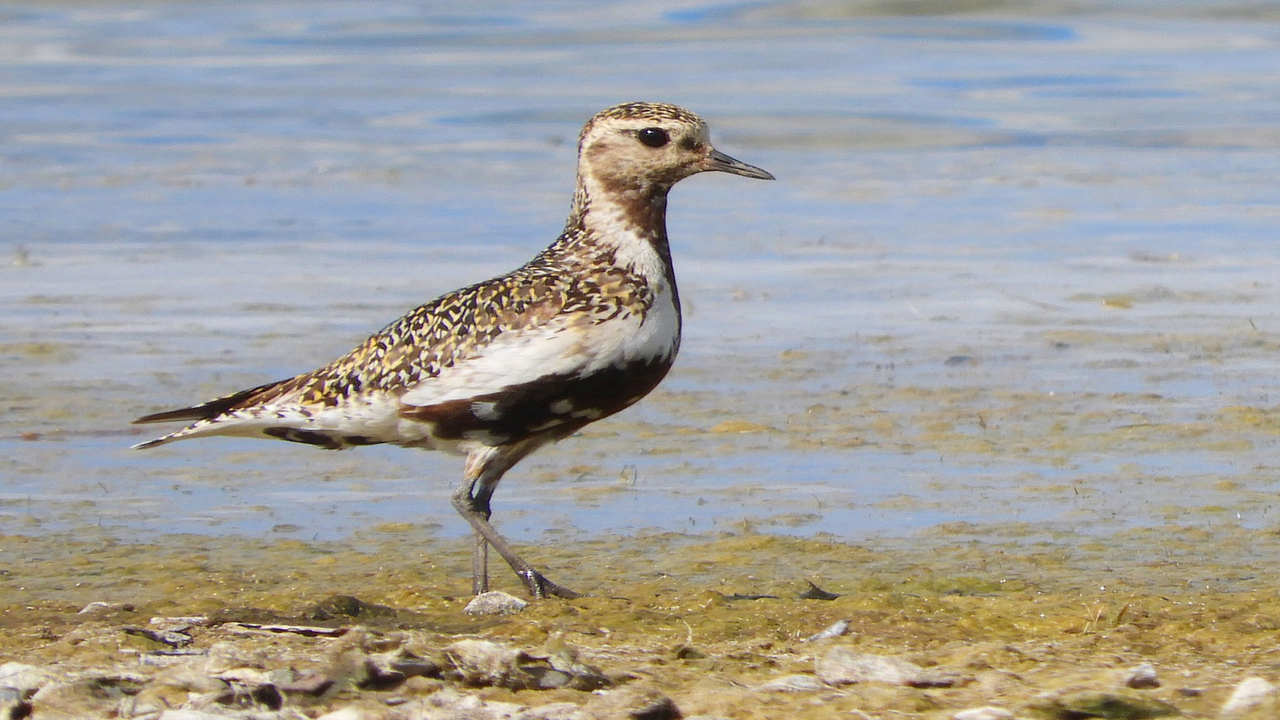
453, 446, 582, 600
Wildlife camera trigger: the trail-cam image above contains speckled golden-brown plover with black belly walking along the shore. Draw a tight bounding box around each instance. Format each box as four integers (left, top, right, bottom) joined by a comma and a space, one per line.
133, 102, 774, 600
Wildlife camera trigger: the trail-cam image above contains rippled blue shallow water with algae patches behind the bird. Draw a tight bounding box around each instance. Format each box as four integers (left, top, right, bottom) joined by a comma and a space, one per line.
0, 3, 1280, 584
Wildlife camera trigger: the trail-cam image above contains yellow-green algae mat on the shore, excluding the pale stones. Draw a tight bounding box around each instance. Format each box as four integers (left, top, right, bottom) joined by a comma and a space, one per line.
0, 524, 1280, 719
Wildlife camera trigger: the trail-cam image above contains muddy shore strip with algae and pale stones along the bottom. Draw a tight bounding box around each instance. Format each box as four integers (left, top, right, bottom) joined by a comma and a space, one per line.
0, 528, 1280, 719
